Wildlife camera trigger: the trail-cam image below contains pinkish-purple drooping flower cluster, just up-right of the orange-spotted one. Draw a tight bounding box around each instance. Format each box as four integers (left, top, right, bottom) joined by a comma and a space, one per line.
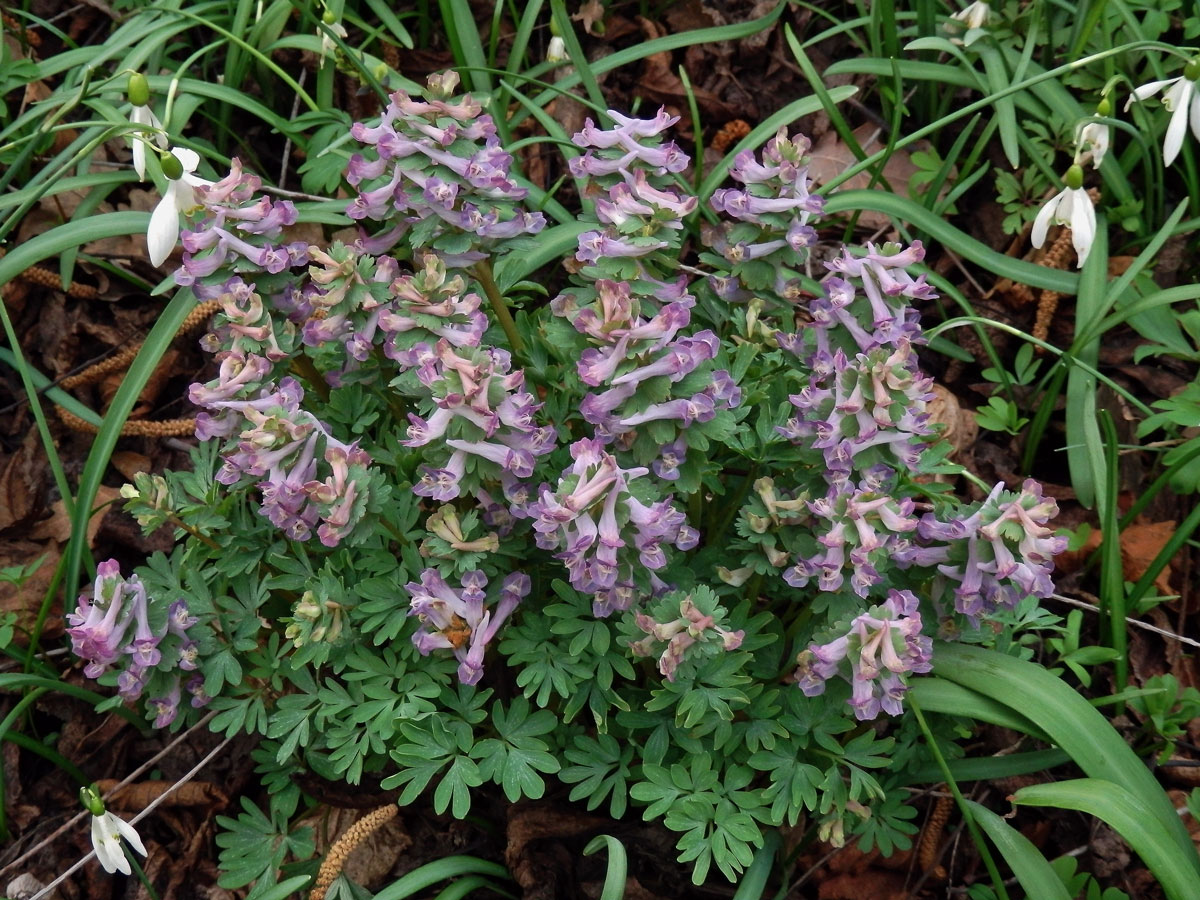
529, 438, 700, 616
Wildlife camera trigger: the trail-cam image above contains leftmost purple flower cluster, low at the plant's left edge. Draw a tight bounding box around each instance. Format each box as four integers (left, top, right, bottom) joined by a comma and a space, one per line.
67, 559, 209, 728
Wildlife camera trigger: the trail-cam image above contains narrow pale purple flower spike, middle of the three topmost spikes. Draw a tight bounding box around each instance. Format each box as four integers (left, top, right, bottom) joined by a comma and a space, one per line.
569, 109, 697, 265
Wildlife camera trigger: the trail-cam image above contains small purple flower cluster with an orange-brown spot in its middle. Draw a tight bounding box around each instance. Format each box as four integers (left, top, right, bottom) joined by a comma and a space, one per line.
404, 569, 530, 684
